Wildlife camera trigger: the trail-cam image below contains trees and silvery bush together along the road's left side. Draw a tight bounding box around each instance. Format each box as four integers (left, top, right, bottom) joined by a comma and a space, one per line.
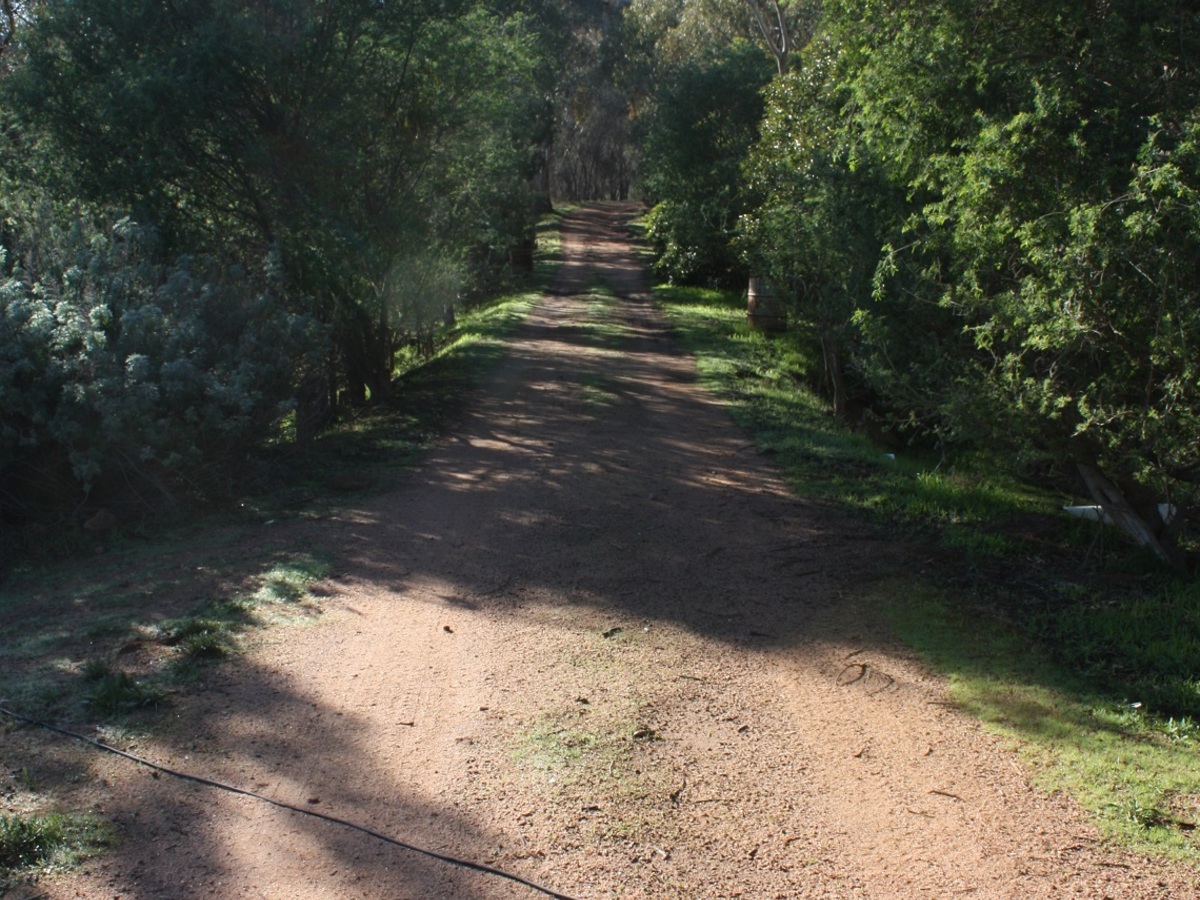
0, 0, 554, 541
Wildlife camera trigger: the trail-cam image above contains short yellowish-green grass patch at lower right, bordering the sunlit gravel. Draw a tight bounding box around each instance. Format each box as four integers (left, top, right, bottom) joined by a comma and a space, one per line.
881, 583, 1200, 862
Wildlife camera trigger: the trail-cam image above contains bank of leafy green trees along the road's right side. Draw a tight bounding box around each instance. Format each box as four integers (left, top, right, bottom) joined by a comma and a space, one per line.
623, 0, 1200, 560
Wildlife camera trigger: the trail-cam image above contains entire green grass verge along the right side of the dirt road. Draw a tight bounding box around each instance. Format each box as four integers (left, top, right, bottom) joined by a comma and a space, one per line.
656, 288, 1200, 862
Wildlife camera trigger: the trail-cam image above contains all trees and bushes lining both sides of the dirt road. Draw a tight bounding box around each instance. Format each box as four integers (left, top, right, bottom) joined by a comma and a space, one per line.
0, 0, 1200, 566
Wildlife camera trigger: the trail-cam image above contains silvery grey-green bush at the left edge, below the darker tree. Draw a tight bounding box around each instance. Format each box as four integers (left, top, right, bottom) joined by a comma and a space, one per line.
0, 198, 319, 517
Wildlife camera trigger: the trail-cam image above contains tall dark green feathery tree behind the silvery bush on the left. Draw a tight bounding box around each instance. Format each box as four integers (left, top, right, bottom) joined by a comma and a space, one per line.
6, 0, 547, 420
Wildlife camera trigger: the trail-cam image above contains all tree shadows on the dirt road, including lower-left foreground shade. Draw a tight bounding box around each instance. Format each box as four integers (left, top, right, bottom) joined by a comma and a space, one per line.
6, 209, 902, 898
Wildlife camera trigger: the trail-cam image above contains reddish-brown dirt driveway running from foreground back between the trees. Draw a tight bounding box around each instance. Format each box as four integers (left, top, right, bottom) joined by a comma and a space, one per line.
14, 206, 1198, 899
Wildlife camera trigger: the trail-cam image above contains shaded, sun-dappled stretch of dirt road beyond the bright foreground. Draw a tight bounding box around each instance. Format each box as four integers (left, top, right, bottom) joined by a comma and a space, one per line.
319, 204, 871, 667
